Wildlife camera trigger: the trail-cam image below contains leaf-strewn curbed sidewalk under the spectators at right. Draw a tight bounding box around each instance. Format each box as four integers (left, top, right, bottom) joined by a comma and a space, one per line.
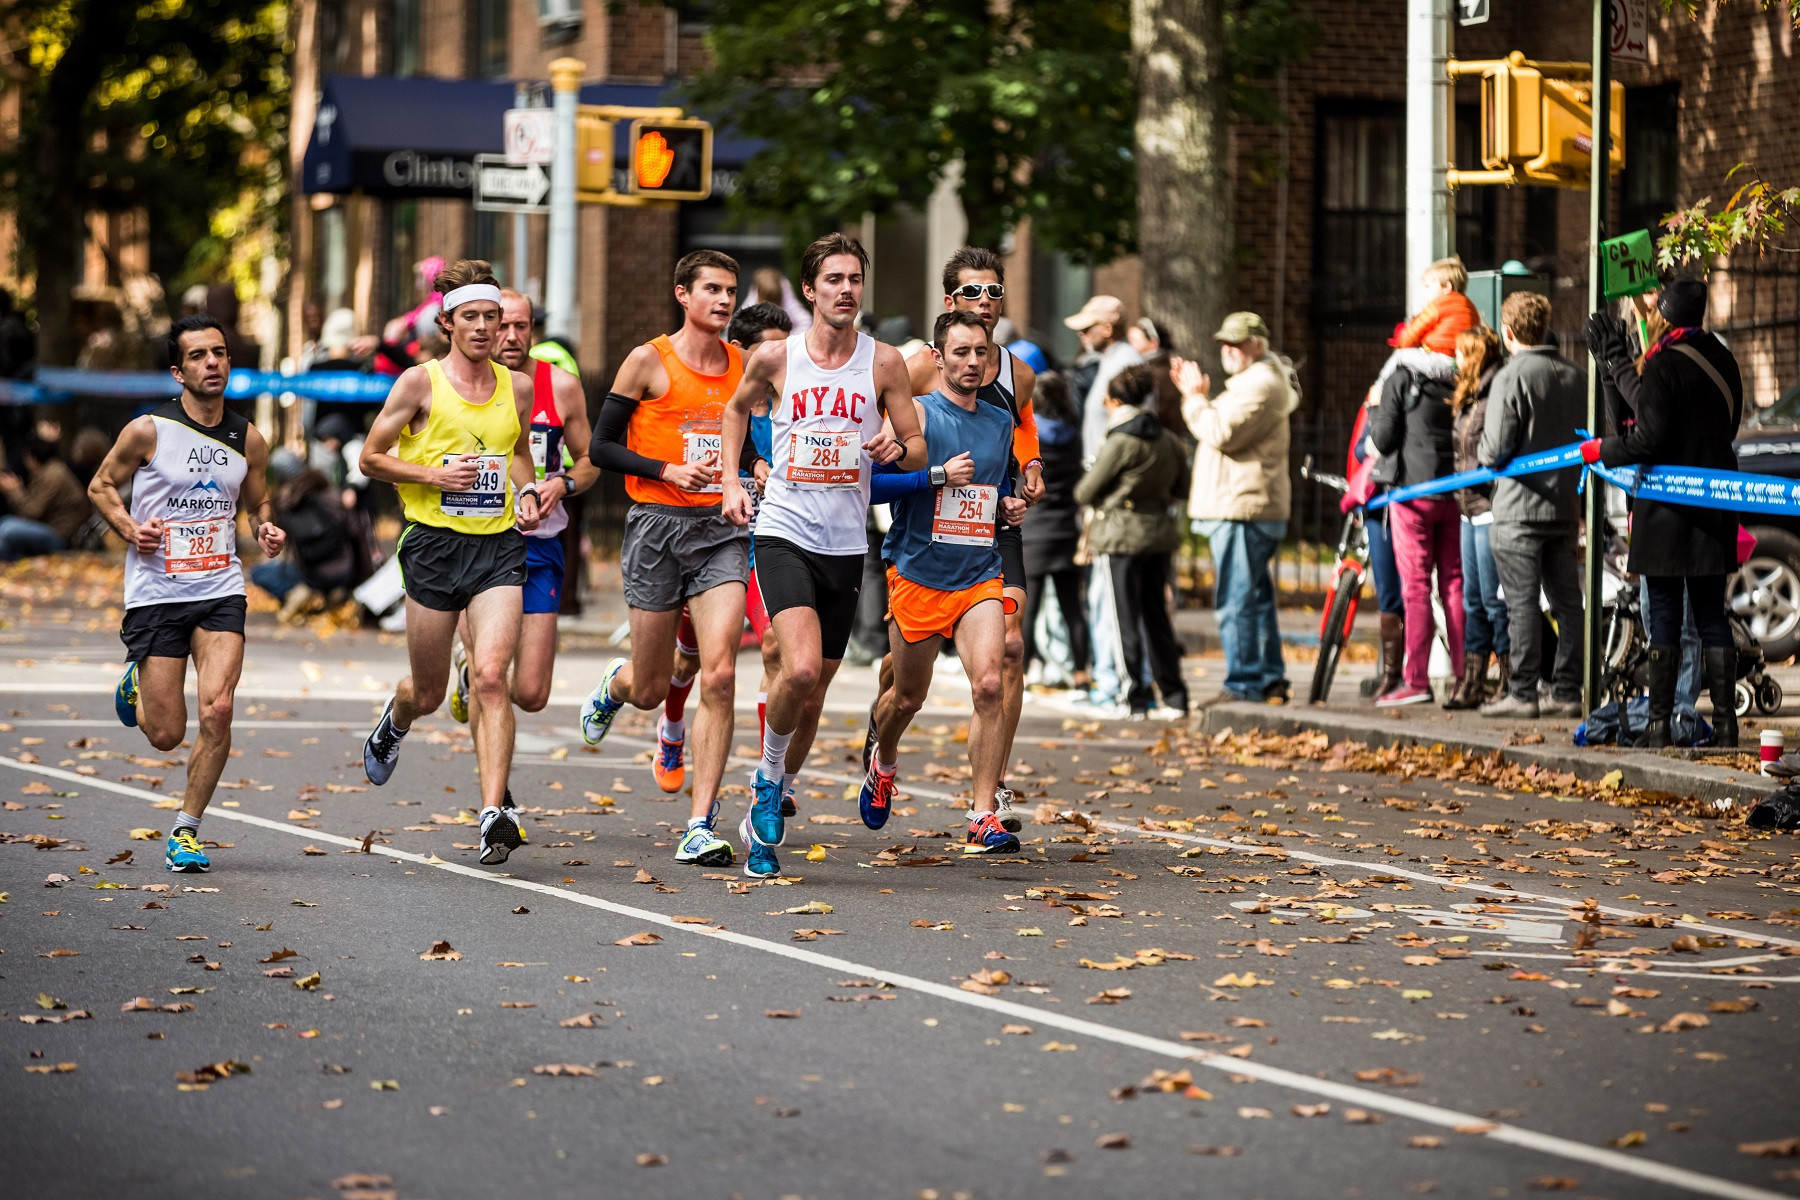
1197, 662, 1800, 802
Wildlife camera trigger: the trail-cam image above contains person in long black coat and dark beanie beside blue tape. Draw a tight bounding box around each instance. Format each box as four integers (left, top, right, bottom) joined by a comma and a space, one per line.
1582, 279, 1744, 747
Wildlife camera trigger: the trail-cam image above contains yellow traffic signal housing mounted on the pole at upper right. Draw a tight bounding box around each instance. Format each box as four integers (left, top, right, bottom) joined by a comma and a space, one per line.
1447, 50, 1625, 187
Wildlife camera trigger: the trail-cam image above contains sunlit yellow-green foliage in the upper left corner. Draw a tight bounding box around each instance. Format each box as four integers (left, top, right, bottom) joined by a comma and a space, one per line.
0, 0, 290, 290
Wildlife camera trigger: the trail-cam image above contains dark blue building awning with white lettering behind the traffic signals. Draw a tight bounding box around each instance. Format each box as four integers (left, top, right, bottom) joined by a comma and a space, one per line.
301, 76, 756, 198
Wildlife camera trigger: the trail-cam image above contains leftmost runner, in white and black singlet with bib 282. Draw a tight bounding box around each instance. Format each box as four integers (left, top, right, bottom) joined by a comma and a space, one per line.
88, 315, 286, 871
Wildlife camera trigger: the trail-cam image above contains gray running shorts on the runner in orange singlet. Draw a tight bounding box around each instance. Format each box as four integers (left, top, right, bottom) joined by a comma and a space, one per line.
619, 504, 751, 612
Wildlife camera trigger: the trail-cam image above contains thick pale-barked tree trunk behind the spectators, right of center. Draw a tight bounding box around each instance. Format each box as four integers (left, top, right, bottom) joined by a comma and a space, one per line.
1130, 0, 1235, 371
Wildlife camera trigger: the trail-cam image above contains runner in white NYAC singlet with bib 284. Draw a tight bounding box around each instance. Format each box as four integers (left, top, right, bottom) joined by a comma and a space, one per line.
722, 234, 925, 876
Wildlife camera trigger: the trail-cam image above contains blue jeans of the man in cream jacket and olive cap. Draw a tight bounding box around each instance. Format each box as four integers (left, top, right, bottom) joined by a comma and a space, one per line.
1195, 520, 1287, 700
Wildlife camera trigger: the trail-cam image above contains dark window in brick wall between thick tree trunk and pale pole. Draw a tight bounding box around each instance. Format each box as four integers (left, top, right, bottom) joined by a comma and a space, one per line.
1312, 101, 1406, 326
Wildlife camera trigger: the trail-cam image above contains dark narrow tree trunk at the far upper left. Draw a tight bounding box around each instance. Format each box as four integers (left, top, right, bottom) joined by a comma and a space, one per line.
31, 5, 119, 367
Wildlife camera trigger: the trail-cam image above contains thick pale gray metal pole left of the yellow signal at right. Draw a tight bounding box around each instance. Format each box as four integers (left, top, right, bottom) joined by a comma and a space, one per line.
1406, 0, 1454, 313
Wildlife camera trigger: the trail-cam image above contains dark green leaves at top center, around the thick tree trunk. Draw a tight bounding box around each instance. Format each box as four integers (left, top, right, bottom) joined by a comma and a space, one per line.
688, 0, 1314, 263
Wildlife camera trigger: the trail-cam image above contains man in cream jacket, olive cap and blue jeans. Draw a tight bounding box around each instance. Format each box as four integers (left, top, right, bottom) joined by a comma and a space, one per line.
1172, 313, 1300, 703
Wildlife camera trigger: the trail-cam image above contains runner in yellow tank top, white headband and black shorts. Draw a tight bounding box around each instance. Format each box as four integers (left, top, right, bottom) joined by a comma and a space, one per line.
362, 259, 556, 864
